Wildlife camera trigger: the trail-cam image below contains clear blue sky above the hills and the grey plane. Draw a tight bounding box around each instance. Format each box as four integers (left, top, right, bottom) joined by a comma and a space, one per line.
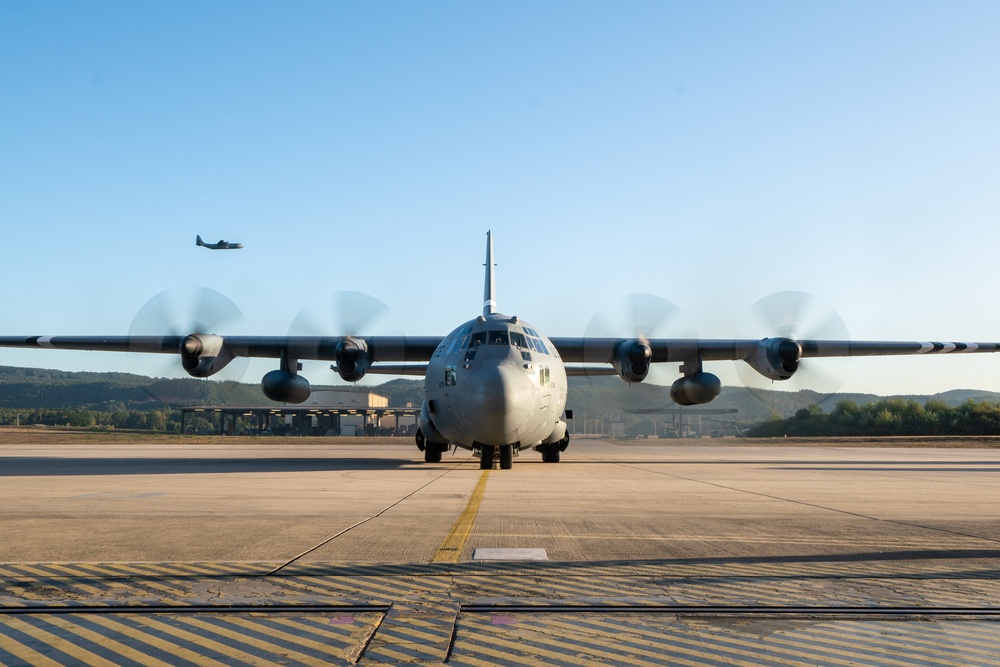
0, 1, 1000, 394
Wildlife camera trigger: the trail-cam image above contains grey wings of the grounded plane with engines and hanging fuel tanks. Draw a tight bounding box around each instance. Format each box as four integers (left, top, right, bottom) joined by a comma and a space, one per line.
7, 334, 1000, 405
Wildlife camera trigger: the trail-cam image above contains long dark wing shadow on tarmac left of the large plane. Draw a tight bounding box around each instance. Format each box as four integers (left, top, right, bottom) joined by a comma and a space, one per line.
0, 456, 414, 477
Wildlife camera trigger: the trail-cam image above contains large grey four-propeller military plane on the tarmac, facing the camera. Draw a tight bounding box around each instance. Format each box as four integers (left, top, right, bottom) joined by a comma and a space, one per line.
0, 232, 1000, 469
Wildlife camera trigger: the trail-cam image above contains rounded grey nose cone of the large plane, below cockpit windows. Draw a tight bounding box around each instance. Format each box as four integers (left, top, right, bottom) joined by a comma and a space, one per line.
463, 364, 533, 445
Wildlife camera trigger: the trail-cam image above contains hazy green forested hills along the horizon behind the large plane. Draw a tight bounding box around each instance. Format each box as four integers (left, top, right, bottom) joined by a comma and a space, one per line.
0, 366, 1000, 424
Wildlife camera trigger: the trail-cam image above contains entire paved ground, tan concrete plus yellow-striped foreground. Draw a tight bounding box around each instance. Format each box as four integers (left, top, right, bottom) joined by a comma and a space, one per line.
0, 438, 1000, 665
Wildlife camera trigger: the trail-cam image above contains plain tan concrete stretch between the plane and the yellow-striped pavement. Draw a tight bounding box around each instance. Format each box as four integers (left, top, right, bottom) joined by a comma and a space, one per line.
0, 438, 1000, 563
